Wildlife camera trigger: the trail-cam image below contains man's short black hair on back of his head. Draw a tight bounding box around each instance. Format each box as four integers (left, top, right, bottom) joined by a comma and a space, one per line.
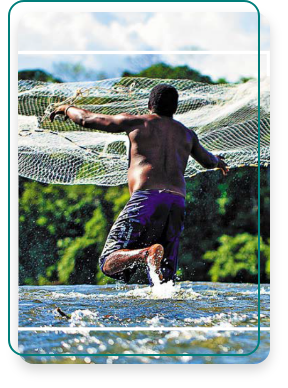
148, 84, 179, 117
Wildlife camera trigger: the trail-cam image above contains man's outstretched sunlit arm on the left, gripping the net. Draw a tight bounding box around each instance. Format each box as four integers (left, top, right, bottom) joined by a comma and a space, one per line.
50, 105, 143, 133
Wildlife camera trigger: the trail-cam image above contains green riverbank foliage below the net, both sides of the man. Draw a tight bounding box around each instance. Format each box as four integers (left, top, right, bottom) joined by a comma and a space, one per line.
19, 168, 270, 284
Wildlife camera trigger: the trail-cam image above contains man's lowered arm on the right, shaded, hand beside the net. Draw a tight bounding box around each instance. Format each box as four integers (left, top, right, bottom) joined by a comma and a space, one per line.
191, 133, 229, 175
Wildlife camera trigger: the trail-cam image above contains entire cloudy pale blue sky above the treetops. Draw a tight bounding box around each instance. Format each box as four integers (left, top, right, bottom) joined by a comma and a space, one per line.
18, 8, 270, 82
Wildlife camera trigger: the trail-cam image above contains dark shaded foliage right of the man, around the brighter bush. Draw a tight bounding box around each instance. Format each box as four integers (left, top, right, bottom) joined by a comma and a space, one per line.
180, 168, 270, 281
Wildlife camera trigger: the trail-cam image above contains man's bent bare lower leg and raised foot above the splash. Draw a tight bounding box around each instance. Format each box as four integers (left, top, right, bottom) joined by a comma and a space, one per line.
103, 244, 164, 280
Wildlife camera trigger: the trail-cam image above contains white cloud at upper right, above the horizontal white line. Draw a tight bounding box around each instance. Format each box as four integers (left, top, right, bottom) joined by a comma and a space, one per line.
135, 12, 257, 50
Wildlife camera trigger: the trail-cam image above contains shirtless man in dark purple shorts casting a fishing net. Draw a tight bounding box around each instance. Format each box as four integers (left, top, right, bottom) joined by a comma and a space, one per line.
51, 84, 228, 283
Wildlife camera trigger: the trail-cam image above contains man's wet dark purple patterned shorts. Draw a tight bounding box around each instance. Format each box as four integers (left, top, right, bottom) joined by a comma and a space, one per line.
100, 190, 185, 283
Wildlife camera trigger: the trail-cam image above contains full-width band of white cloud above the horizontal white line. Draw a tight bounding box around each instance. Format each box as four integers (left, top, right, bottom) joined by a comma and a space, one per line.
19, 12, 269, 50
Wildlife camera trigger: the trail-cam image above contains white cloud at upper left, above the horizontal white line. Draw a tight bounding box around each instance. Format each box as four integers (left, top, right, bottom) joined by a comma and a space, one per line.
19, 12, 143, 51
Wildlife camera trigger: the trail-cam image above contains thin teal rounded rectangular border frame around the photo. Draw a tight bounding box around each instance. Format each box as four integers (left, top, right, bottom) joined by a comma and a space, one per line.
8, 0, 261, 357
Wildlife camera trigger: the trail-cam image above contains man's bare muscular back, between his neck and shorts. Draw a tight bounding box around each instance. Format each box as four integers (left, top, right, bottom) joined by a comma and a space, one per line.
128, 115, 193, 197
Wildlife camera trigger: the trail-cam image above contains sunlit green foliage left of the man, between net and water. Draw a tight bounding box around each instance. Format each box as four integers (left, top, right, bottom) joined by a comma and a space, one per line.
19, 178, 129, 284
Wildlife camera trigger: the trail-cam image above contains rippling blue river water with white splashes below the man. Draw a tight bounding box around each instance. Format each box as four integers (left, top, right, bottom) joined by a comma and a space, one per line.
18, 282, 270, 364
